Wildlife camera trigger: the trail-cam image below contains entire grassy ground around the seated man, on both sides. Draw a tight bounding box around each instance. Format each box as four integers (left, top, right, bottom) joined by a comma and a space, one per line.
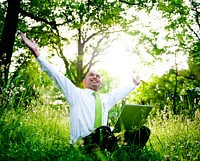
0, 106, 200, 161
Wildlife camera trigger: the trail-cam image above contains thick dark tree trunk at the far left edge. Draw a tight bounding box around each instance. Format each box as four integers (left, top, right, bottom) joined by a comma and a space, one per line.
0, 0, 21, 95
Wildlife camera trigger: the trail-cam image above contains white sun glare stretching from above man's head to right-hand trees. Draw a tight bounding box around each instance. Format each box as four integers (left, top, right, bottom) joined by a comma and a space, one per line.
96, 36, 188, 86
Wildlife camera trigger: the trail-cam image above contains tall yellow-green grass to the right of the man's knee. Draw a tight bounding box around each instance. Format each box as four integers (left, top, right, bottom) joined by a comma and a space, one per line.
149, 112, 200, 161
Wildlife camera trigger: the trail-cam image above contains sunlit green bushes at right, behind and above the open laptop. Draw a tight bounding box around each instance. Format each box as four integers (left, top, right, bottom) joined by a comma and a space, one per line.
130, 69, 200, 118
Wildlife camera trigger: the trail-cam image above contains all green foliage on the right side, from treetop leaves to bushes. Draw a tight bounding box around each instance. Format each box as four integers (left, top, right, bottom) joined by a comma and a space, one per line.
126, 0, 200, 117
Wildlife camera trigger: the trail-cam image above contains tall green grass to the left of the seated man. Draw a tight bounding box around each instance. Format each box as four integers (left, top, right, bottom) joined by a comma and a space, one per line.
0, 107, 69, 160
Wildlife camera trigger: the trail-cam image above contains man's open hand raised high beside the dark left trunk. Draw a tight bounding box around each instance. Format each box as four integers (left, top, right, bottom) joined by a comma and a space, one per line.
19, 32, 40, 58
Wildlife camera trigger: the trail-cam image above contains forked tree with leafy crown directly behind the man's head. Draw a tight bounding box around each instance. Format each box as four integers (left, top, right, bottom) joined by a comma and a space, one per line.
17, 0, 131, 86
